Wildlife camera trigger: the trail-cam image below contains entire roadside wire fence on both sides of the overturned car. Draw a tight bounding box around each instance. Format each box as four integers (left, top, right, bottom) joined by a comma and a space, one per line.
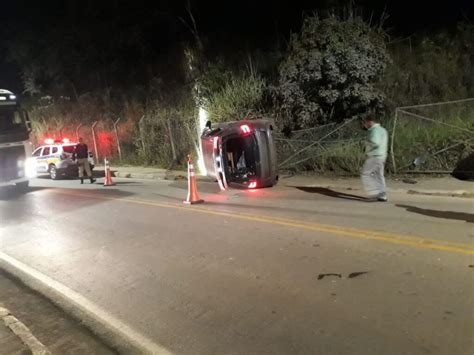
31, 98, 474, 175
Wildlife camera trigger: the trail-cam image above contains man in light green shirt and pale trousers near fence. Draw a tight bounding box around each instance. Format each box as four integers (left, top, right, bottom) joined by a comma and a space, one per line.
361, 118, 388, 202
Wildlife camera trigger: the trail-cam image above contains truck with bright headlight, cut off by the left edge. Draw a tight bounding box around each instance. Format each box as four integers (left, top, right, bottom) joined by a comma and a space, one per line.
0, 89, 36, 190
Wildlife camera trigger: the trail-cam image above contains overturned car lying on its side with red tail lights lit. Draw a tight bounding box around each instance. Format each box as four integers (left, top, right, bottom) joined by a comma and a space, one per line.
201, 119, 278, 190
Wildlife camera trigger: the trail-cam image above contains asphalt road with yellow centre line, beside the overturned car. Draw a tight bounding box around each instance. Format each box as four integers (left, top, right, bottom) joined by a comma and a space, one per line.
0, 179, 474, 354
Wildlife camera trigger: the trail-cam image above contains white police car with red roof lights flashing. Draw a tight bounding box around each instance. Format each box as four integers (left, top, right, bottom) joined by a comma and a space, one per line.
33, 138, 94, 180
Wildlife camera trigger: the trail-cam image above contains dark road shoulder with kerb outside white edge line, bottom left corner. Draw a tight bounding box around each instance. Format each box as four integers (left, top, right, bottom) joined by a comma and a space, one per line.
0, 270, 114, 354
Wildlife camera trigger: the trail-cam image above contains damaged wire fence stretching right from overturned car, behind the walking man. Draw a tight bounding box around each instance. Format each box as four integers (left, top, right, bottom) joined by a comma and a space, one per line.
277, 98, 474, 174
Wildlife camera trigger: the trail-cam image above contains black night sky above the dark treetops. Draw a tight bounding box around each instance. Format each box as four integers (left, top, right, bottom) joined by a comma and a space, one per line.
0, 0, 474, 93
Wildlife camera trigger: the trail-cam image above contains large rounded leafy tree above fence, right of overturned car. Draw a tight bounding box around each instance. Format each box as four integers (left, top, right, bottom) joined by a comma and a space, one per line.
277, 15, 390, 129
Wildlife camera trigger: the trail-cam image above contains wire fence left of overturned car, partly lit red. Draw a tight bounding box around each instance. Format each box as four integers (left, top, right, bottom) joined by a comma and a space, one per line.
32, 114, 197, 168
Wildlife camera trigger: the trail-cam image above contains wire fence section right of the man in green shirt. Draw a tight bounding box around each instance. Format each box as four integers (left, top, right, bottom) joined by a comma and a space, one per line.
390, 98, 474, 173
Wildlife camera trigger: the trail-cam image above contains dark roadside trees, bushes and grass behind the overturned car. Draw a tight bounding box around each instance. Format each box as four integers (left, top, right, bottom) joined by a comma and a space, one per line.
7, 6, 474, 174
